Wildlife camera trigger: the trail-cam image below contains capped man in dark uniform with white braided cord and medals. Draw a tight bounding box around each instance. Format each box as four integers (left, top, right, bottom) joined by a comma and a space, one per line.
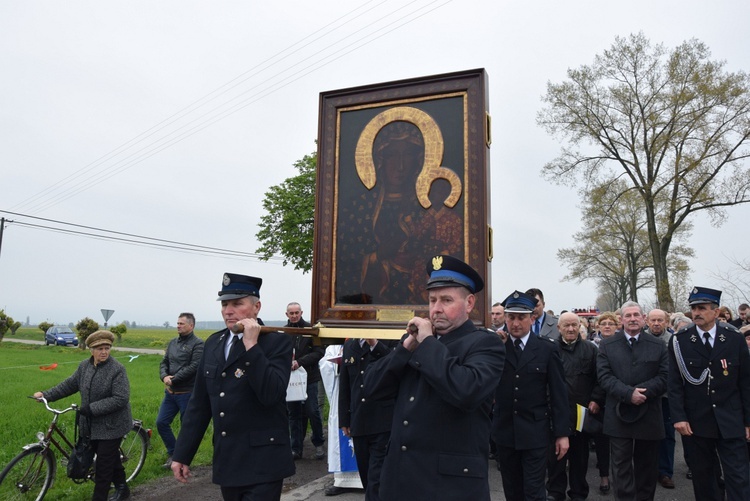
669, 287, 750, 500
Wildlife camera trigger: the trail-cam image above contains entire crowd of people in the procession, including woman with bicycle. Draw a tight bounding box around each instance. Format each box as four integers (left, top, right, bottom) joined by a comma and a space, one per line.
30, 264, 750, 501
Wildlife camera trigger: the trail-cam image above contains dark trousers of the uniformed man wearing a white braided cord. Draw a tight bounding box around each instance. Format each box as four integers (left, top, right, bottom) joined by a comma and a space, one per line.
682, 435, 750, 501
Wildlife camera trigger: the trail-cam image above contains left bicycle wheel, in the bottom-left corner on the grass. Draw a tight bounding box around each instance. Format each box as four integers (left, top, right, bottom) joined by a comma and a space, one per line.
0, 445, 56, 501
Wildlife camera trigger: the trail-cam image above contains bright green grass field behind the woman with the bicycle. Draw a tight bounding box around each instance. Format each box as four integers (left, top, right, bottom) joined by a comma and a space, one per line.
0, 342, 213, 501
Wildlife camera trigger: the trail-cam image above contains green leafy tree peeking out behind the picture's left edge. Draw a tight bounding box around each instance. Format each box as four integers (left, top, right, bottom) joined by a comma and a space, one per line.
256, 149, 317, 272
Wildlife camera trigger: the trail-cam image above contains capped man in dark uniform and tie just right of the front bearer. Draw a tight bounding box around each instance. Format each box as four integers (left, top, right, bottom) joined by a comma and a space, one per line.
494, 291, 570, 501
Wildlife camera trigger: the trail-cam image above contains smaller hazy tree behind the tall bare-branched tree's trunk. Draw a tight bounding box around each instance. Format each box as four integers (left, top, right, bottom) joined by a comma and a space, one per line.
557, 180, 693, 309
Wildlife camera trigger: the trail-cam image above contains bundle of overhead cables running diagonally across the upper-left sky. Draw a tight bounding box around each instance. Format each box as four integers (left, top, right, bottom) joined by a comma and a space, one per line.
8, 0, 452, 212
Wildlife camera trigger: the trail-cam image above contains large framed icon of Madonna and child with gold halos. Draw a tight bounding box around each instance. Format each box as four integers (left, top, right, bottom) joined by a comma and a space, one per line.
312, 69, 492, 328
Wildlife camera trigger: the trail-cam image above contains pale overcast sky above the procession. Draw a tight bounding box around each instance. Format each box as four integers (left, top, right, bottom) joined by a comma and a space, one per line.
0, 0, 750, 325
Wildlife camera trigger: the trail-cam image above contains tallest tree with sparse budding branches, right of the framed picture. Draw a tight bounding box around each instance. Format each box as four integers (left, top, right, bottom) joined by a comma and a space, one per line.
537, 33, 750, 310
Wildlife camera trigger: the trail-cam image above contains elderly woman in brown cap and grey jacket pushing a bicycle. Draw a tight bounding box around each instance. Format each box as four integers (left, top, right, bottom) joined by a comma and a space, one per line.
34, 331, 133, 501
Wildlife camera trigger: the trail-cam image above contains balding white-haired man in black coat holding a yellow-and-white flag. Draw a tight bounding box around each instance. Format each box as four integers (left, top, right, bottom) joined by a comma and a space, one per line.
547, 312, 604, 501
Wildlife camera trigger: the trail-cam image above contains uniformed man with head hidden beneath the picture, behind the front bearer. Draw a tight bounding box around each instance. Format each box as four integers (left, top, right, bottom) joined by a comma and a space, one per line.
339, 339, 394, 501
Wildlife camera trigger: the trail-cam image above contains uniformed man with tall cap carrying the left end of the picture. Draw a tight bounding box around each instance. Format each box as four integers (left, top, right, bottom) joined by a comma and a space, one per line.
172, 273, 294, 501
